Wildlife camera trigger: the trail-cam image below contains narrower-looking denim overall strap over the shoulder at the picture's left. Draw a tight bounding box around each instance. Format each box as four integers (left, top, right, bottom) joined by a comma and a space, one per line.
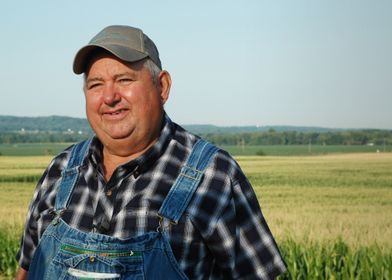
55, 138, 92, 212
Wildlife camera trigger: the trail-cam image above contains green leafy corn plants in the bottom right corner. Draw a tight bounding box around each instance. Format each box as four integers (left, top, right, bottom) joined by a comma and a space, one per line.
279, 239, 392, 280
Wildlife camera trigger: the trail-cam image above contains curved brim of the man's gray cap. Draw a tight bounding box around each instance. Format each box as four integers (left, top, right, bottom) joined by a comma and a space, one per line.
73, 44, 148, 74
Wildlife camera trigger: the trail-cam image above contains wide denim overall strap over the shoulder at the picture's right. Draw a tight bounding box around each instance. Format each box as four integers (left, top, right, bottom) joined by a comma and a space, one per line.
158, 139, 218, 223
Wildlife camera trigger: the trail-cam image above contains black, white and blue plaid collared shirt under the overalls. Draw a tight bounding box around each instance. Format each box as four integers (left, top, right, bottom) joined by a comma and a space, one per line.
17, 117, 286, 279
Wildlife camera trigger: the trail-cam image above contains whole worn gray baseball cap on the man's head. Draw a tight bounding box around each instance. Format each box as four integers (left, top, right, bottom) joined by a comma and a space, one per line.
73, 25, 162, 74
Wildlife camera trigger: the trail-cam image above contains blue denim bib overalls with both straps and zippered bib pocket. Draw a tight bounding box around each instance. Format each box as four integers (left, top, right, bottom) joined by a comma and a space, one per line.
28, 140, 218, 280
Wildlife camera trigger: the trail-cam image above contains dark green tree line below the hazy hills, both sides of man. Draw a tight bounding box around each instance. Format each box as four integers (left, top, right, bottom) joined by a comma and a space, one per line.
0, 129, 392, 145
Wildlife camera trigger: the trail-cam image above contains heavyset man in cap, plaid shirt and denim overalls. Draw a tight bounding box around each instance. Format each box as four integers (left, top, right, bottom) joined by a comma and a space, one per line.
17, 26, 286, 279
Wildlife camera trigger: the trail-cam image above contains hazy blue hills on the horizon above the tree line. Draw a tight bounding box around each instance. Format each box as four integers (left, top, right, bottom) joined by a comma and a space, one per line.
0, 116, 342, 134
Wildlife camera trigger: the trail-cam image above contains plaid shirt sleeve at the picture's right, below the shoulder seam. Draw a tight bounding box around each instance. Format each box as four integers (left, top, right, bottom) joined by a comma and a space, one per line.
207, 176, 286, 279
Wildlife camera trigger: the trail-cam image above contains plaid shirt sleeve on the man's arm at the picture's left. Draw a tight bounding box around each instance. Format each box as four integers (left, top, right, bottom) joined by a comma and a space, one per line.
16, 153, 67, 270
